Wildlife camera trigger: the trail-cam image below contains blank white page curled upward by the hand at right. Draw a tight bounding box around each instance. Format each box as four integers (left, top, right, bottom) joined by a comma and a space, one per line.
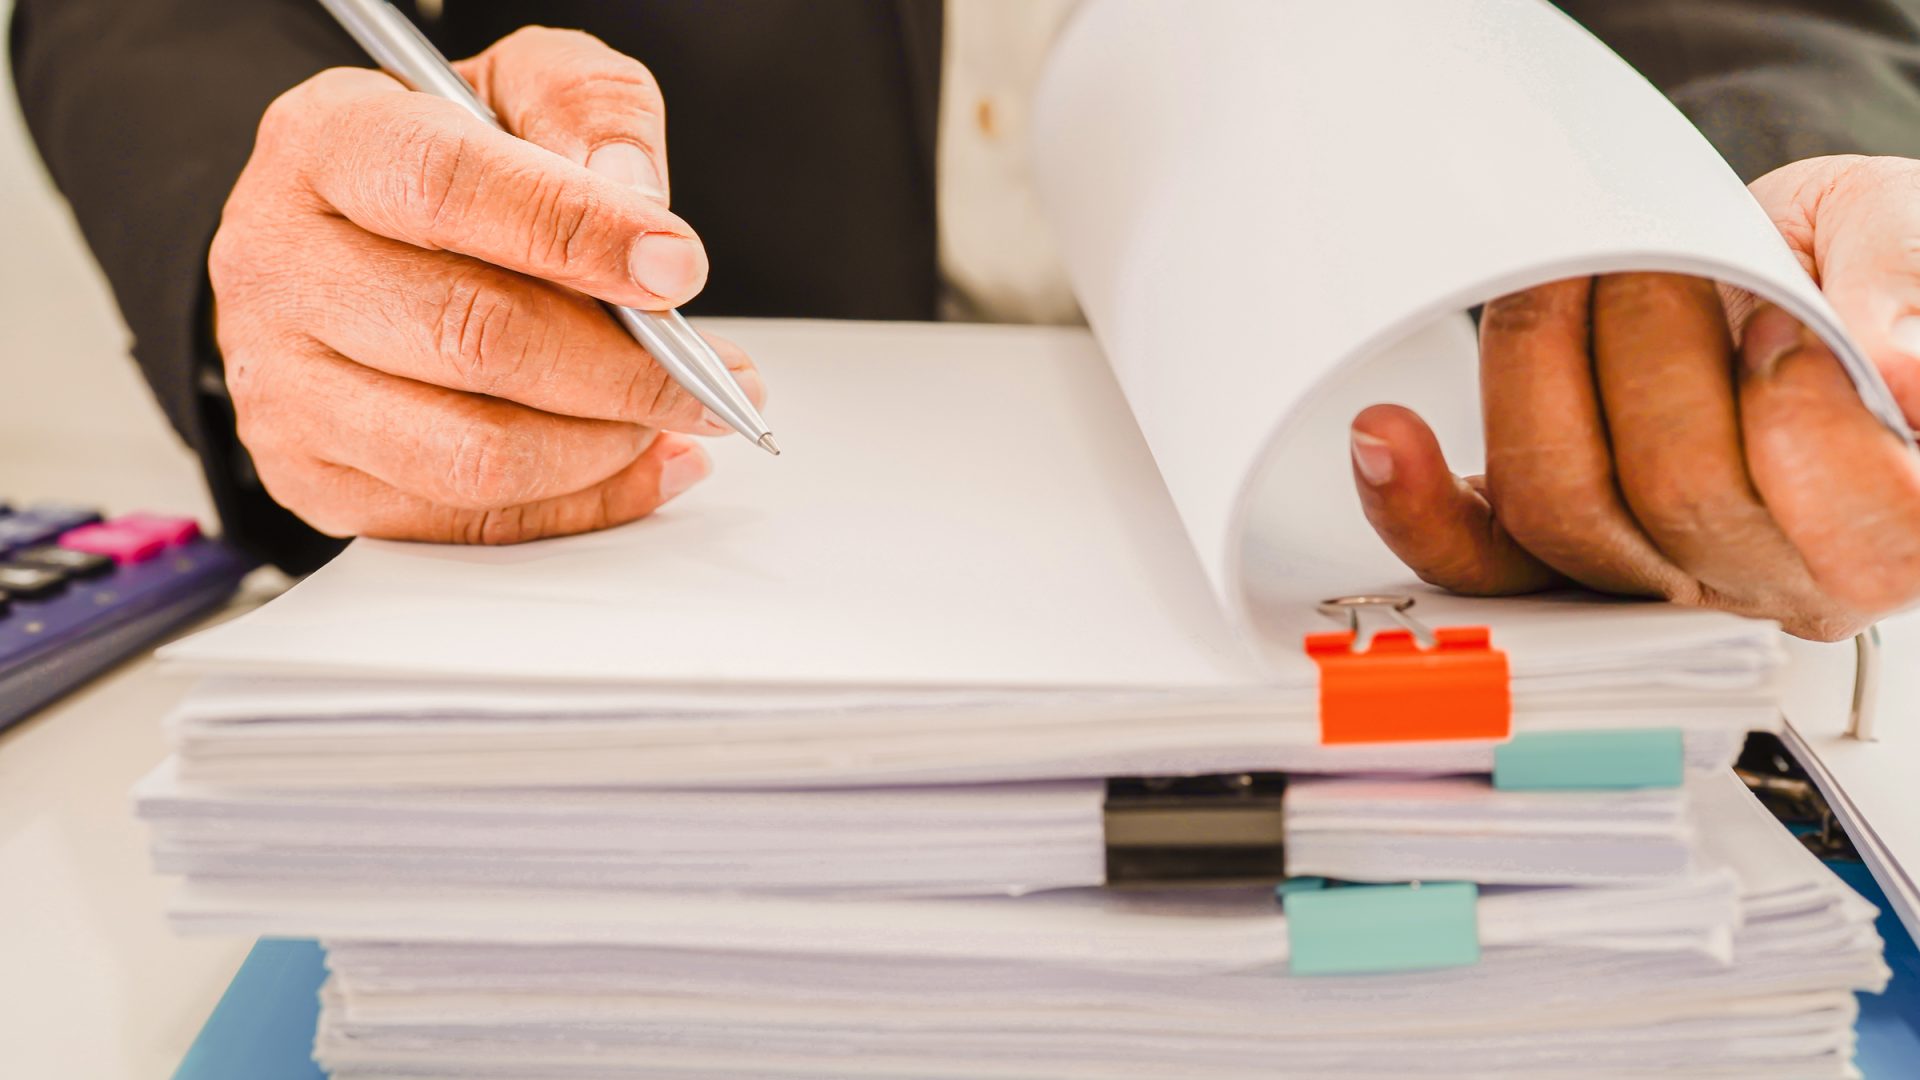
1035, 0, 1905, 657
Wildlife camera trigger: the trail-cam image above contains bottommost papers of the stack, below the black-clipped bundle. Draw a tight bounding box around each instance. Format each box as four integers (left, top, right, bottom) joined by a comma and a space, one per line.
153, 774, 1885, 1080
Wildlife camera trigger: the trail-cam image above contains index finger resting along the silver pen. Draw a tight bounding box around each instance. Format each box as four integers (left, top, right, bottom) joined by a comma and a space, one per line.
288, 73, 707, 309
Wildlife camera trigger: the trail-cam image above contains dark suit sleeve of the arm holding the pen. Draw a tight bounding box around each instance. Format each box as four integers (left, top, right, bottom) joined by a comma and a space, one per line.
12, 0, 365, 571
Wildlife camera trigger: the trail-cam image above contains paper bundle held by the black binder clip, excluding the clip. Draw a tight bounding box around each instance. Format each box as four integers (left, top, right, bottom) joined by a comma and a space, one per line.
138, 767, 1695, 896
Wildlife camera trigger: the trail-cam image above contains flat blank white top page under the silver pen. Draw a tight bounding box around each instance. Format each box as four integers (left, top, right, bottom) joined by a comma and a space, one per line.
165, 321, 1778, 691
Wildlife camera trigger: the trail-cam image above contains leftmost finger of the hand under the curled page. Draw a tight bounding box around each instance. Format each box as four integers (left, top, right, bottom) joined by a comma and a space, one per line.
1352, 405, 1567, 596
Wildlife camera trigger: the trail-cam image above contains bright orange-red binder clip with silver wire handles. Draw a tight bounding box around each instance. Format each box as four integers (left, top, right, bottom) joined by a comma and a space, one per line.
1306, 596, 1513, 746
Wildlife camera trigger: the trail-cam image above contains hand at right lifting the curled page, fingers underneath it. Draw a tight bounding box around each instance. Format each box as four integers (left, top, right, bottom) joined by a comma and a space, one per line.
1352, 158, 1920, 640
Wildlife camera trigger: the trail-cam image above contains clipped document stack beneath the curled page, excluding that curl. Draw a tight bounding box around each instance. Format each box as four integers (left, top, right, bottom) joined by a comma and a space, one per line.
138, 323, 1885, 1080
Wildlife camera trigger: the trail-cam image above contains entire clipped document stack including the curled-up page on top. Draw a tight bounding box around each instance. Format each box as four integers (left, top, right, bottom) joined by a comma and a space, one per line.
138, 0, 1887, 1080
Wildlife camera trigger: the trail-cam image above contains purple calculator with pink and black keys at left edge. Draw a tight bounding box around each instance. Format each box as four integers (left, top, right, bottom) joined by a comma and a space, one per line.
0, 503, 253, 728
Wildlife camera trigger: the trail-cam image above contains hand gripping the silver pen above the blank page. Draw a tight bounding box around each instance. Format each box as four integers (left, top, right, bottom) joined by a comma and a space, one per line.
207, 29, 762, 544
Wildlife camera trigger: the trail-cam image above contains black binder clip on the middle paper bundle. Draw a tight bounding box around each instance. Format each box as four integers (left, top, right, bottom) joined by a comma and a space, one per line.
1104, 773, 1286, 886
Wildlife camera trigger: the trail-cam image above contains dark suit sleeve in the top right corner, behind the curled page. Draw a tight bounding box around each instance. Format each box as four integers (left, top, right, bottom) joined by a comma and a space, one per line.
1559, 0, 1920, 181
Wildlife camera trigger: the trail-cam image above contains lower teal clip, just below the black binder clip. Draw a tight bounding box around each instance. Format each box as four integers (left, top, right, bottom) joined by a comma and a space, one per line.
1284, 882, 1480, 974
